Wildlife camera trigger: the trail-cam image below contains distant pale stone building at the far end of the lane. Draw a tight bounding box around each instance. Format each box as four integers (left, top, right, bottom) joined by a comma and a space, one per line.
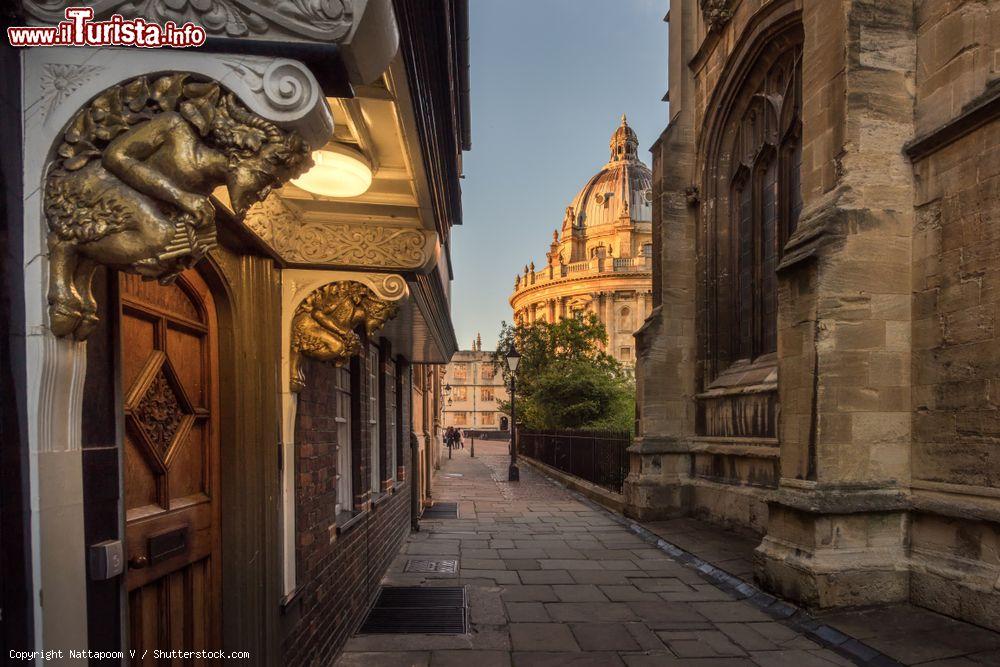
441, 335, 510, 431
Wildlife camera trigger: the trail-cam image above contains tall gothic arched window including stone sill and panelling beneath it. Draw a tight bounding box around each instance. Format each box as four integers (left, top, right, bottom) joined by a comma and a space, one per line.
696, 28, 802, 438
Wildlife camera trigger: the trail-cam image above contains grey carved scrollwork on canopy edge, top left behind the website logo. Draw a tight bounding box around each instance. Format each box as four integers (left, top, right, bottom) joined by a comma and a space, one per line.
24, 0, 354, 42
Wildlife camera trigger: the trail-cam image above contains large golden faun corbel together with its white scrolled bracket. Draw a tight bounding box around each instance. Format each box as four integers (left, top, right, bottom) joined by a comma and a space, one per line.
36, 50, 333, 340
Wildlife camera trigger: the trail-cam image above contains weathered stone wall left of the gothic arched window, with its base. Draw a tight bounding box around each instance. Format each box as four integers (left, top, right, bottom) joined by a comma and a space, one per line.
625, 0, 799, 532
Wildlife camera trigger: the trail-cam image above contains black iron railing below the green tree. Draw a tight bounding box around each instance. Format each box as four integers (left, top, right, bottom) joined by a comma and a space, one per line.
517, 430, 632, 493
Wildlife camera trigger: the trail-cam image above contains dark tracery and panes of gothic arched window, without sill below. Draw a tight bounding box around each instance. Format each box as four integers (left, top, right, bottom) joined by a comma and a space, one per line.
709, 44, 802, 375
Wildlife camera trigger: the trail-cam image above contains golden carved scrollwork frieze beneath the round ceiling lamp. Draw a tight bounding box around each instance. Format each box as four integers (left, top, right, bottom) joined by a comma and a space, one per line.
244, 195, 437, 270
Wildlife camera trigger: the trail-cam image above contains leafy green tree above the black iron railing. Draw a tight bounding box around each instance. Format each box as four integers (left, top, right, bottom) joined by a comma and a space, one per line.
494, 314, 635, 430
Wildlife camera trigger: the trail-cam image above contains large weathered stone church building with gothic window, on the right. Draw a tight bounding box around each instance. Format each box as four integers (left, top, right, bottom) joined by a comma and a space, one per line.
626, 0, 1000, 629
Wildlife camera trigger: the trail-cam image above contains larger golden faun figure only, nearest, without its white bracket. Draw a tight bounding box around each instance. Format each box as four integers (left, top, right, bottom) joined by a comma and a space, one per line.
44, 73, 312, 340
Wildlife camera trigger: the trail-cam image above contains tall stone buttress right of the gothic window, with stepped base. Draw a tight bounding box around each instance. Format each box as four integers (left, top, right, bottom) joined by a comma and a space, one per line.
755, 0, 916, 606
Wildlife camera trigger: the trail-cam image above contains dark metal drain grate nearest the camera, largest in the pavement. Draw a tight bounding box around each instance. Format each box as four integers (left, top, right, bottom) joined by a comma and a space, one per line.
360, 586, 469, 635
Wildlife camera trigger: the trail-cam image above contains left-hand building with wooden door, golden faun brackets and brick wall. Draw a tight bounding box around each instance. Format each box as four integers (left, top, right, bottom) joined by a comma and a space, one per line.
0, 0, 471, 665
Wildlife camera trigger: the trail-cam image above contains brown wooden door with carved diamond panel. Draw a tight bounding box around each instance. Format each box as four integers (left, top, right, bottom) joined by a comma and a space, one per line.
119, 270, 221, 664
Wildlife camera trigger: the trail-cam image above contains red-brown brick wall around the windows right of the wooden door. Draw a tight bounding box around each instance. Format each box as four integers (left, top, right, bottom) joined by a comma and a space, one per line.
282, 357, 410, 665
